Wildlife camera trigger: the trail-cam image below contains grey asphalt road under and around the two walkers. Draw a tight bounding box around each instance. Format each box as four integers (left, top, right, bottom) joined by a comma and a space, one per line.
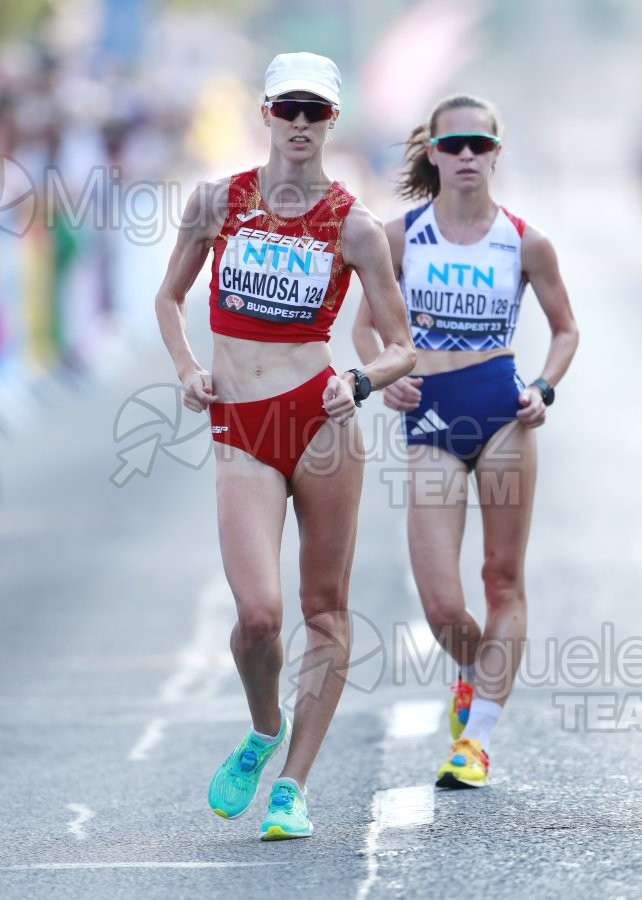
0, 199, 642, 900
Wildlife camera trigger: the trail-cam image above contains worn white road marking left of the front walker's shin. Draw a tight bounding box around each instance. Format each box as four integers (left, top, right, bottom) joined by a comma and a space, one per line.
127, 575, 235, 762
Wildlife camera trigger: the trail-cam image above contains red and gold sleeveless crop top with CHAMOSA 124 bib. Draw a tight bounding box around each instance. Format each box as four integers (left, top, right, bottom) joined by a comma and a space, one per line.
210, 169, 355, 343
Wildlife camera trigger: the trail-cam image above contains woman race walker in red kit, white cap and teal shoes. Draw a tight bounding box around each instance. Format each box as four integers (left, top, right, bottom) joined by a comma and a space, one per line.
156, 53, 416, 840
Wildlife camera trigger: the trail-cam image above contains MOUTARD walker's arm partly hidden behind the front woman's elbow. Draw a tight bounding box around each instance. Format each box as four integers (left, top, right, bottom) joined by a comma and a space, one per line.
352, 218, 421, 412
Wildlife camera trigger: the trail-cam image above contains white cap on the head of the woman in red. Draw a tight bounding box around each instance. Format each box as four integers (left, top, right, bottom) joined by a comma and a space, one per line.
265, 53, 341, 106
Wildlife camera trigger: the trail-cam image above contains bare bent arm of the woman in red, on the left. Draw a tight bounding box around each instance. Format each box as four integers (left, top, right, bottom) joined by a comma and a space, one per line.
156, 182, 227, 412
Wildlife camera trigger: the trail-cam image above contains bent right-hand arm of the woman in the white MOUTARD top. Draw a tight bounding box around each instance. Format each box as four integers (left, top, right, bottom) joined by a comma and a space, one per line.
517, 226, 579, 428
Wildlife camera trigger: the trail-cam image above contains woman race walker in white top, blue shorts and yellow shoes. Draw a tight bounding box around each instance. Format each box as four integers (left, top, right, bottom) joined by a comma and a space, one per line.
354, 95, 578, 788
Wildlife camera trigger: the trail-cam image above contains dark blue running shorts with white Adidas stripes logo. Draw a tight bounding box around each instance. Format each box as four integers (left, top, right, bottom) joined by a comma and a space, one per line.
401, 356, 524, 472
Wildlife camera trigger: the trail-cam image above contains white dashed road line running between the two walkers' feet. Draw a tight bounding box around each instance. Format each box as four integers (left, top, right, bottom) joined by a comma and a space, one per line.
356, 700, 446, 900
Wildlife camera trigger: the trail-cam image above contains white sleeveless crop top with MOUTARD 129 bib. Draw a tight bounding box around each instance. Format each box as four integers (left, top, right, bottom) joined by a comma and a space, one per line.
400, 202, 526, 350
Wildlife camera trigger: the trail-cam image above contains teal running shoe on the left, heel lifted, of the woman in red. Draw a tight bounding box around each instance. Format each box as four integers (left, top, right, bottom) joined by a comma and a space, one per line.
209, 707, 290, 819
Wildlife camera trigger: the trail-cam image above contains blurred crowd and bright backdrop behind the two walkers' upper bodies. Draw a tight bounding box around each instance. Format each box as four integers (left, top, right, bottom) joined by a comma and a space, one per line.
0, 0, 642, 433
